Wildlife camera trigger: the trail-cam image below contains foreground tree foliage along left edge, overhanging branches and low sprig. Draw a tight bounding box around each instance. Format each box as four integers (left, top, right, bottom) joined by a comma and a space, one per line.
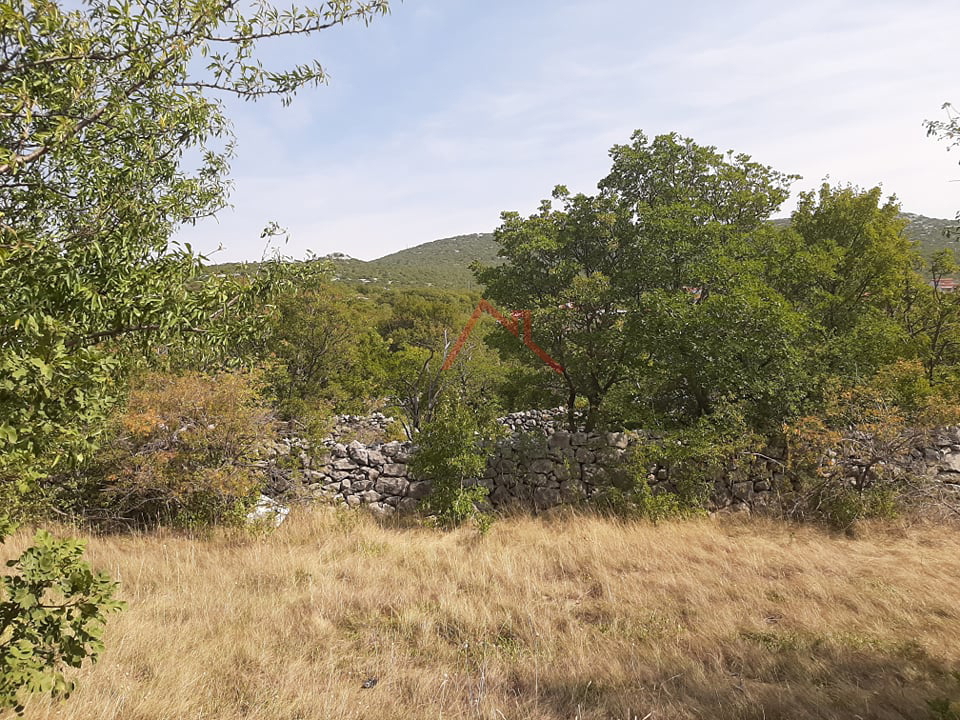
0, 0, 388, 706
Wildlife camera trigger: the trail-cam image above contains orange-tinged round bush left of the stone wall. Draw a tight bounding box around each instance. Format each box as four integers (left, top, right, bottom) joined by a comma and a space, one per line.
81, 372, 276, 527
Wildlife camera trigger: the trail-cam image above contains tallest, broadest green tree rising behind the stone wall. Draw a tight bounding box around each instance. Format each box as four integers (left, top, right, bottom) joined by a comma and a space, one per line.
477, 132, 802, 427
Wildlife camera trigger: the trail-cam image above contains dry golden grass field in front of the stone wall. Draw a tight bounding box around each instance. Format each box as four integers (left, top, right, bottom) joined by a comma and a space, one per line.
6, 511, 960, 720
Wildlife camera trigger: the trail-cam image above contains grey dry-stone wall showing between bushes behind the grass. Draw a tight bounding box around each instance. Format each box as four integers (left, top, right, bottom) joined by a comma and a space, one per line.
280, 408, 960, 517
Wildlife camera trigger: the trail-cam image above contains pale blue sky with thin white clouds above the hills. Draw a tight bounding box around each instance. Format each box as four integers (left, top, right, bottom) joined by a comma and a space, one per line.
178, 0, 960, 262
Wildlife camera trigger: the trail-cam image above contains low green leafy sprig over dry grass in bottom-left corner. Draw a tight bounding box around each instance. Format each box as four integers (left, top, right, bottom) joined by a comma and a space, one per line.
0, 531, 125, 712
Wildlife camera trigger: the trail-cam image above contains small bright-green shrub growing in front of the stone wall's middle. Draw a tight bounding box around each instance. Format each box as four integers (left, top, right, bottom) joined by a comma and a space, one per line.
410, 400, 502, 532
